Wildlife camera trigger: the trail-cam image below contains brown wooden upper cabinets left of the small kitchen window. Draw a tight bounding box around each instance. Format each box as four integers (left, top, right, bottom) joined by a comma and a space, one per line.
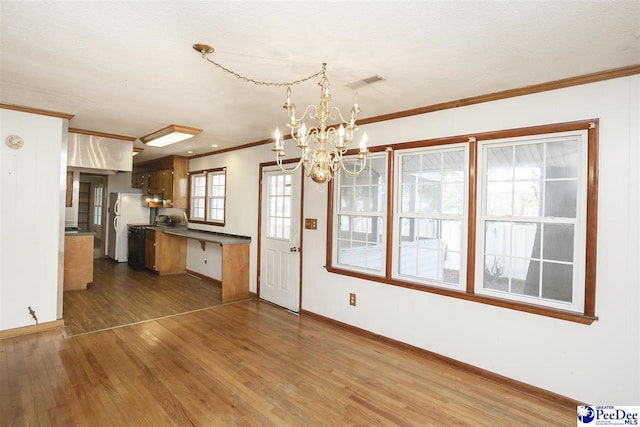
131, 156, 189, 209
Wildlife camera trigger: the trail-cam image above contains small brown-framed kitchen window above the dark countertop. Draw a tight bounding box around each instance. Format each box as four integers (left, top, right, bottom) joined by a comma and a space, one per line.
189, 169, 226, 225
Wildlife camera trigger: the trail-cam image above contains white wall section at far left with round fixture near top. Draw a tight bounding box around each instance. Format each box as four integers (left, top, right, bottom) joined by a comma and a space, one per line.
0, 109, 67, 330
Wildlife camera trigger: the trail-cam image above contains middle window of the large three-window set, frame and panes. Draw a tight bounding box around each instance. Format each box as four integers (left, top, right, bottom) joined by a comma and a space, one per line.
393, 145, 468, 288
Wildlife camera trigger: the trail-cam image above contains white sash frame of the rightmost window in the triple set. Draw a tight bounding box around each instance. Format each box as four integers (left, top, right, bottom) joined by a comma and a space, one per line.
474, 130, 588, 313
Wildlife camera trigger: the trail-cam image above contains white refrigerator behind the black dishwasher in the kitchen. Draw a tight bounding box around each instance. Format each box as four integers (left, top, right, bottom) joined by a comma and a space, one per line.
107, 193, 150, 262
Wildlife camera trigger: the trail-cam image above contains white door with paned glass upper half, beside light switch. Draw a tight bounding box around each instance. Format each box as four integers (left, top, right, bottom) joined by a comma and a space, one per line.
260, 167, 302, 312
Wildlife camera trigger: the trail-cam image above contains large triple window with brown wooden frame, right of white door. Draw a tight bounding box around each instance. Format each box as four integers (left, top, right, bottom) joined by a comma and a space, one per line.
327, 121, 597, 323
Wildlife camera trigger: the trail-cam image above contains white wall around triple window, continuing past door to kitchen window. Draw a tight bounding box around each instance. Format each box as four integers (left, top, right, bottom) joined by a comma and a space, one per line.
188, 75, 640, 405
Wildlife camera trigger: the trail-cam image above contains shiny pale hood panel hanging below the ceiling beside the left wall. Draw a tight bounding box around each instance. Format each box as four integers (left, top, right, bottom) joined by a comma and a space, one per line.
67, 132, 133, 172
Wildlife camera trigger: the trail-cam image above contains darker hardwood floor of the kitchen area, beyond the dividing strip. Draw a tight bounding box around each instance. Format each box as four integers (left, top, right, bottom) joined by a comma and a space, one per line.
63, 258, 222, 335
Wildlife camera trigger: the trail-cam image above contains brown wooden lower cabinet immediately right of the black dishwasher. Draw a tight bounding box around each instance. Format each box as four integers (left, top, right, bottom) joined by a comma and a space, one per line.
144, 230, 187, 275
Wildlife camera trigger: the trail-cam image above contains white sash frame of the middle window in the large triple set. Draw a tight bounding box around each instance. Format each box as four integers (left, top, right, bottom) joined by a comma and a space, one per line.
391, 143, 469, 291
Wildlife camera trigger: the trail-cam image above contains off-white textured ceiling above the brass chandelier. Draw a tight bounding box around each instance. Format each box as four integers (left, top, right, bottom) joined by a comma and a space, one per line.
0, 0, 640, 161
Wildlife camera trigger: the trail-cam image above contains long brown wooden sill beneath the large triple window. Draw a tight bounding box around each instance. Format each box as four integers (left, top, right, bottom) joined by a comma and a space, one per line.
325, 266, 598, 325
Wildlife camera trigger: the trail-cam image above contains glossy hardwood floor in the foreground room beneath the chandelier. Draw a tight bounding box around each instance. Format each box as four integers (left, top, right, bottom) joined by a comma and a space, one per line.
0, 300, 576, 426
